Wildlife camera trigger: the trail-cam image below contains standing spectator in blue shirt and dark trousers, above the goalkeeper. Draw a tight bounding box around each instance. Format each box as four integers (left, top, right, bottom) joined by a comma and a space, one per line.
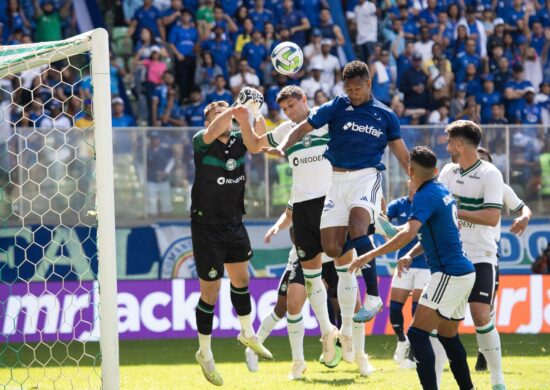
168, 9, 199, 100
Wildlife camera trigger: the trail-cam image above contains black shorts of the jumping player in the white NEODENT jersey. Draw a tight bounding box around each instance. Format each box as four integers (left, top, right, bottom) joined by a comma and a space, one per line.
292, 196, 325, 261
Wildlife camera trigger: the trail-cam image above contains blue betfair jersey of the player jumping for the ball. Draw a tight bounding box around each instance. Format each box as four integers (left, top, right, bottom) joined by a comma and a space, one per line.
308, 95, 401, 170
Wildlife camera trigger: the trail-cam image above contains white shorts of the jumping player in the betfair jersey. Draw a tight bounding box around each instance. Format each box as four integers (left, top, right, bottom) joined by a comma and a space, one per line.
321, 168, 382, 229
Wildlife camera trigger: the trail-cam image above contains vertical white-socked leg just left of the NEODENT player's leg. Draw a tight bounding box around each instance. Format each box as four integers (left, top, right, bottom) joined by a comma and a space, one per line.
287, 262, 307, 380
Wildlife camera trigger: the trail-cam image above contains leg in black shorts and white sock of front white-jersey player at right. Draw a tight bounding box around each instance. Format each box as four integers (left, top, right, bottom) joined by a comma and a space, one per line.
469, 263, 506, 389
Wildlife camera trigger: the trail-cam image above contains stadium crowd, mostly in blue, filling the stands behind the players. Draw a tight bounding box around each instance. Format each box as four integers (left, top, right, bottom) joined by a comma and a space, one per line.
0, 0, 550, 216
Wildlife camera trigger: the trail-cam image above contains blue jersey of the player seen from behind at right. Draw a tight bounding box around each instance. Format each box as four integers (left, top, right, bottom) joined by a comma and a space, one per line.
409, 179, 474, 276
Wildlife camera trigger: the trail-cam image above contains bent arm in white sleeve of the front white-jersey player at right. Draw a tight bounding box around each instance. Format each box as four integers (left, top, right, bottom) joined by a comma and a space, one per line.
458, 169, 504, 226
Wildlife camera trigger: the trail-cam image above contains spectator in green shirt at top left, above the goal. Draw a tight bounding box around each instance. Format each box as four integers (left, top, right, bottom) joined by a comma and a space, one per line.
33, 0, 73, 42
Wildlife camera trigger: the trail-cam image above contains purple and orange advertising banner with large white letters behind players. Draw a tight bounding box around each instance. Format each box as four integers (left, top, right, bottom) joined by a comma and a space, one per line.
0, 275, 550, 342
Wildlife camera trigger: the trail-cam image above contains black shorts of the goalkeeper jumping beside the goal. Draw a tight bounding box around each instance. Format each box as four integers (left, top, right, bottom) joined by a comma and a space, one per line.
191, 221, 252, 281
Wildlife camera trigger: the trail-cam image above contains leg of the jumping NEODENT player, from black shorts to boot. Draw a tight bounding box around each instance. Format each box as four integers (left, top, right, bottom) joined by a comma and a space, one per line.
292, 197, 337, 362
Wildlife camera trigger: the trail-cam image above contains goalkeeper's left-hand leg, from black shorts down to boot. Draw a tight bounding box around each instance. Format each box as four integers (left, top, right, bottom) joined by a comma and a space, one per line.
191, 222, 225, 386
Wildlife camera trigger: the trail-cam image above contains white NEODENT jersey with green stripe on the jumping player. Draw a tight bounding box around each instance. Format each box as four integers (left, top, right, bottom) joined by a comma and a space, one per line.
267, 110, 332, 204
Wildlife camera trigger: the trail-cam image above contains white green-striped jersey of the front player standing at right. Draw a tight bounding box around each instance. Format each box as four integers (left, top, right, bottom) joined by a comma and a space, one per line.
439, 160, 504, 265
